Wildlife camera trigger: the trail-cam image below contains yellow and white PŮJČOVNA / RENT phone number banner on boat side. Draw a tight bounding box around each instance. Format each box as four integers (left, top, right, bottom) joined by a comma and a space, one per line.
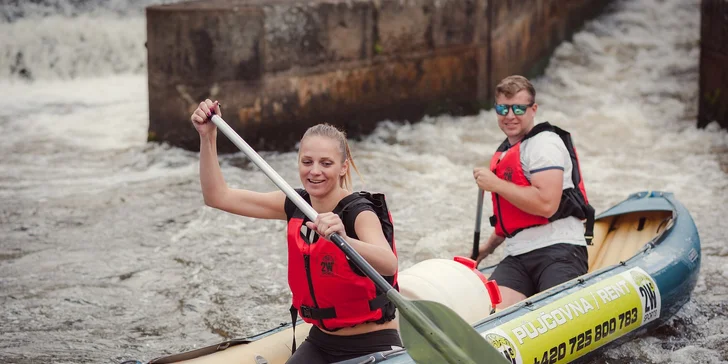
481, 268, 661, 364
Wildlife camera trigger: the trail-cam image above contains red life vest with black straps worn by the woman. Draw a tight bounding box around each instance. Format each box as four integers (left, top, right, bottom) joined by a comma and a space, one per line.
286, 189, 398, 332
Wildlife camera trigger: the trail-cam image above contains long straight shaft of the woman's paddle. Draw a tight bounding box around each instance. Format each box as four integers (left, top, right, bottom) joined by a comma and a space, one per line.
211, 115, 473, 364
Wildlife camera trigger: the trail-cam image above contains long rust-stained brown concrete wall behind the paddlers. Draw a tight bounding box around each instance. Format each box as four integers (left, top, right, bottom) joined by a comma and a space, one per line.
146, 0, 610, 153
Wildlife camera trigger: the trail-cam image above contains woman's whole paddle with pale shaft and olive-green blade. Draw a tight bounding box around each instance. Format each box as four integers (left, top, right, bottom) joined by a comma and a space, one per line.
211, 115, 507, 364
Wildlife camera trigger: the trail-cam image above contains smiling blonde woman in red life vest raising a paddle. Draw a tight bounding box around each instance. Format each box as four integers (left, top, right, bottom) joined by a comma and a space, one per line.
191, 99, 402, 364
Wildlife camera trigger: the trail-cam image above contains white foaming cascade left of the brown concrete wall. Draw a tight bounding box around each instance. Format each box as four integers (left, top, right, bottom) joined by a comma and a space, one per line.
0, 0, 181, 80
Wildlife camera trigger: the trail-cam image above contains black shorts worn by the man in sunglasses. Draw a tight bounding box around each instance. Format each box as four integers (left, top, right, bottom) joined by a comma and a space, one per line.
490, 244, 589, 297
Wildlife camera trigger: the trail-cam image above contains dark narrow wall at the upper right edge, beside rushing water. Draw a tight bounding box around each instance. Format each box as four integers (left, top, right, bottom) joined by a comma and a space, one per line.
698, 0, 728, 129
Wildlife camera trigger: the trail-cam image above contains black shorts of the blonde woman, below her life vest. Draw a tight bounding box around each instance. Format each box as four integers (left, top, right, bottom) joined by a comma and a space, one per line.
286, 326, 402, 364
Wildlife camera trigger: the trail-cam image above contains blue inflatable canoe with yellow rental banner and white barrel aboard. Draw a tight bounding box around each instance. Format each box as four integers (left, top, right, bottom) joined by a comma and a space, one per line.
141, 192, 701, 364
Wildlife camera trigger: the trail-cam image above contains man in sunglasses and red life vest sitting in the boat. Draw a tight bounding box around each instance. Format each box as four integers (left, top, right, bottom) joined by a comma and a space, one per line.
473, 76, 594, 309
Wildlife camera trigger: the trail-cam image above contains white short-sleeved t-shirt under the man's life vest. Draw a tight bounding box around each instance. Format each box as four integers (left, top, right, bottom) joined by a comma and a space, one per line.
501, 132, 586, 256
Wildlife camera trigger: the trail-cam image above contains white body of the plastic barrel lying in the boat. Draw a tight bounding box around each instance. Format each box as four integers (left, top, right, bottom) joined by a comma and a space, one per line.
397, 259, 491, 324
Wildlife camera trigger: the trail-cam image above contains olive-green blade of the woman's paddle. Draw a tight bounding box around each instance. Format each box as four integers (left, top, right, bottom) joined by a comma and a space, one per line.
399, 300, 509, 364
